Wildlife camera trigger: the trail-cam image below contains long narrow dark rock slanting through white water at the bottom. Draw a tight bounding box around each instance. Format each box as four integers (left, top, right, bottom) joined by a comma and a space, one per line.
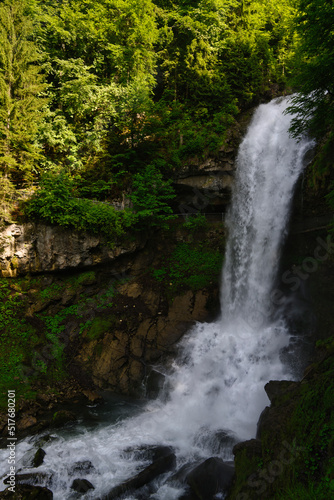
101, 452, 176, 500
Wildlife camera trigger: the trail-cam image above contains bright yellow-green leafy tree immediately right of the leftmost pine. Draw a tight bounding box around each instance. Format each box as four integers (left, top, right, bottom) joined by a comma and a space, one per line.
39, 0, 158, 171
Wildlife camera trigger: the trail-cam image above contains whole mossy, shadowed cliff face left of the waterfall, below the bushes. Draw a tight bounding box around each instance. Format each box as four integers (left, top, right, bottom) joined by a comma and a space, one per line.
0, 221, 224, 434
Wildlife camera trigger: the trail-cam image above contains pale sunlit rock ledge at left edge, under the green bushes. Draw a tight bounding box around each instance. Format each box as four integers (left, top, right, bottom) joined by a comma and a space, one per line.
0, 223, 143, 277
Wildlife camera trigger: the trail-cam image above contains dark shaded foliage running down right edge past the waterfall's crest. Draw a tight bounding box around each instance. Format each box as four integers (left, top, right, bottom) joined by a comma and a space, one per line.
289, 0, 334, 232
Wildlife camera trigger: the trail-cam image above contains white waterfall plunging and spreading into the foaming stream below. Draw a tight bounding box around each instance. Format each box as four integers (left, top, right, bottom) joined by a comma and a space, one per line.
0, 95, 312, 500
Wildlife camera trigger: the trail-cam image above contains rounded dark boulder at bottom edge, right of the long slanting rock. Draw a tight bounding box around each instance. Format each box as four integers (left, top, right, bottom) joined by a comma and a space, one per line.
186, 457, 234, 500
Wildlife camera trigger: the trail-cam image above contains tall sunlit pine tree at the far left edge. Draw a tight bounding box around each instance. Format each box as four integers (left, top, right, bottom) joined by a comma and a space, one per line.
0, 0, 45, 185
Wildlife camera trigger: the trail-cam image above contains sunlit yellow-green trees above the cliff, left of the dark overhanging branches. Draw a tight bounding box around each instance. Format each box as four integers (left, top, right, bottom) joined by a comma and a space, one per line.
0, 0, 302, 225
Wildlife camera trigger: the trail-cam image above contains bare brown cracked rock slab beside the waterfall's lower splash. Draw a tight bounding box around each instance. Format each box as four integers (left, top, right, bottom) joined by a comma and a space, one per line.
75, 282, 218, 394
